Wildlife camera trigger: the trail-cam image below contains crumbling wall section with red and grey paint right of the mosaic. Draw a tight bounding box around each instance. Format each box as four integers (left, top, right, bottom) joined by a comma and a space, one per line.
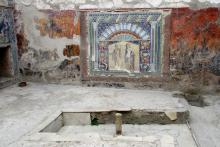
170, 8, 220, 91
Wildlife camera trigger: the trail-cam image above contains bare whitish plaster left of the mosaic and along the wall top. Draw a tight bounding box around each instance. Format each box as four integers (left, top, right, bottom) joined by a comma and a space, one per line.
15, 0, 220, 86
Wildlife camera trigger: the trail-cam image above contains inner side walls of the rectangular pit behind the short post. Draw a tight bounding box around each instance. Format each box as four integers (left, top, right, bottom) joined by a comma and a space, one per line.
40, 109, 189, 132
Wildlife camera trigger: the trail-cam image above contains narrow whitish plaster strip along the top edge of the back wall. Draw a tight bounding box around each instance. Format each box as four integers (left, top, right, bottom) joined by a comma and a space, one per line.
15, 0, 220, 10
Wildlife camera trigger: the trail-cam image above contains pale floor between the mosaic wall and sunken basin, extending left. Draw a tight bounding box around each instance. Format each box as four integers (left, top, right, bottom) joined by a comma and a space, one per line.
0, 83, 188, 147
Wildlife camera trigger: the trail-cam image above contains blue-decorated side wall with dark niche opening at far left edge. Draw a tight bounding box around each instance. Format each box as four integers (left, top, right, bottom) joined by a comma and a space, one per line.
0, 7, 18, 84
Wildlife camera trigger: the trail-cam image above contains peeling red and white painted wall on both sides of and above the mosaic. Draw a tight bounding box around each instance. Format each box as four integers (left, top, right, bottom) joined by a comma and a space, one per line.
15, 0, 220, 92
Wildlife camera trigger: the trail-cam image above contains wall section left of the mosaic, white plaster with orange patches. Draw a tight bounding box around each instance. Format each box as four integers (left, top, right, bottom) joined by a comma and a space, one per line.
15, 6, 80, 82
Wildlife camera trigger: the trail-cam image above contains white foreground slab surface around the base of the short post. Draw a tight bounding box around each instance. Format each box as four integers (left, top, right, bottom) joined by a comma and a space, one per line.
20, 124, 196, 147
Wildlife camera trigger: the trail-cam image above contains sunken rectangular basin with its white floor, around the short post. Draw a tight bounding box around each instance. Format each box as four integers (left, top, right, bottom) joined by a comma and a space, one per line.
24, 109, 196, 147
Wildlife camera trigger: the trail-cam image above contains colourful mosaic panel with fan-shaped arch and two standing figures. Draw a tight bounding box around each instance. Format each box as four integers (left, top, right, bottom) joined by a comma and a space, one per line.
88, 12, 162, 74
